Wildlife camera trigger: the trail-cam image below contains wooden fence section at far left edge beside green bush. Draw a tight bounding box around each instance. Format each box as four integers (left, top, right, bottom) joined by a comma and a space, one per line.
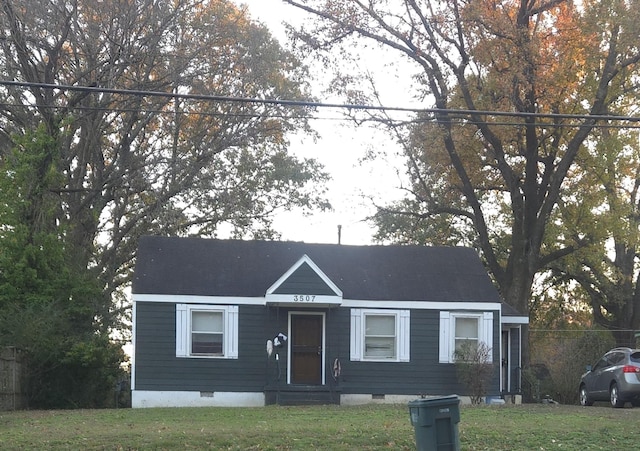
0, 346, 27, 411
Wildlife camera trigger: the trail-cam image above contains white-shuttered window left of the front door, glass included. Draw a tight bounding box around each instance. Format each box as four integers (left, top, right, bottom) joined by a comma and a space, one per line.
176, 304, 238, 359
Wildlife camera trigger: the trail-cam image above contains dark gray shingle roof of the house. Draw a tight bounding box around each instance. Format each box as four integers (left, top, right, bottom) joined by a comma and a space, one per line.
132, 237, 500, 303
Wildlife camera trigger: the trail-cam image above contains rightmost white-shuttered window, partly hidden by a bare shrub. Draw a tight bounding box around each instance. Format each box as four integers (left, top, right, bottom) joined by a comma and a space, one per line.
439, 311, 493, 363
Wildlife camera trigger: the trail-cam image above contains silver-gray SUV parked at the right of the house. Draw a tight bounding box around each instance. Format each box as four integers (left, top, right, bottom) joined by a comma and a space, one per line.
580, 348, 640, 407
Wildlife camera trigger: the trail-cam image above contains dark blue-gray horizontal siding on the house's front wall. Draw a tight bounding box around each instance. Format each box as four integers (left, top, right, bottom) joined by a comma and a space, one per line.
135, 302, 500, 395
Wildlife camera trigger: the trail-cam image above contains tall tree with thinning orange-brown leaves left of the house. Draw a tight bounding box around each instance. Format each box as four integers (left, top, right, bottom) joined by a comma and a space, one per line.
0, 0, 327, 322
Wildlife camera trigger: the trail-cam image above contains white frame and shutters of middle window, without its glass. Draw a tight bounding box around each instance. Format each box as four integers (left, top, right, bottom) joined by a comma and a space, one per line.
350, 308, 411, 362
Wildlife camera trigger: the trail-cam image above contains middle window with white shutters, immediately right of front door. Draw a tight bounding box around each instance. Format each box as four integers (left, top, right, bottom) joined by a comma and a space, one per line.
350, 309, 410, 362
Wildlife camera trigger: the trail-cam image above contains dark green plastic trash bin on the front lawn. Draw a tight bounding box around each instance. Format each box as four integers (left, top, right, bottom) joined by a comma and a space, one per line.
409, 395, 460, 451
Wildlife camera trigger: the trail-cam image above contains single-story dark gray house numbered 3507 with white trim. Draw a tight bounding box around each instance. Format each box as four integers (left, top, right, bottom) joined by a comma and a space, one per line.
132, 237, 528, 407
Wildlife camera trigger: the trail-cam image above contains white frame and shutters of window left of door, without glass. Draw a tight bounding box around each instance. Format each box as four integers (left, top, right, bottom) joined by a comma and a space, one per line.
176, 304, 238, 359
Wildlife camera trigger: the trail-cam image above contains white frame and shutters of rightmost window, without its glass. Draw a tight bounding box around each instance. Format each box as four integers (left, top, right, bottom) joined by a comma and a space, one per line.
438, 311, 493, 363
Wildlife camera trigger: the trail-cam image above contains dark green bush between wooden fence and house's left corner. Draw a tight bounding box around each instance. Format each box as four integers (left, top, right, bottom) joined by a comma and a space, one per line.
0, 300, 125, 408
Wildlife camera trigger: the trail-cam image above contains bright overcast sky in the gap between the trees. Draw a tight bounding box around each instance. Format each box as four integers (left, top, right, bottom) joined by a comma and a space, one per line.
234, 0, 416, 245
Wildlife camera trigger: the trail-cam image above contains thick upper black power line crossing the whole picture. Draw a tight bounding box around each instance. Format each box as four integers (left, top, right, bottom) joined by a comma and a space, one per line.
0, 80, 640, 128
